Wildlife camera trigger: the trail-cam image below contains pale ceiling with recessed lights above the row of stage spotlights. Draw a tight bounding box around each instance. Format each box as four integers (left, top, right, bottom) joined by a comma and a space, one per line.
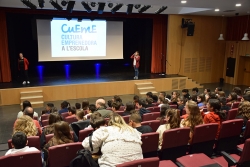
0, 0, 250, 16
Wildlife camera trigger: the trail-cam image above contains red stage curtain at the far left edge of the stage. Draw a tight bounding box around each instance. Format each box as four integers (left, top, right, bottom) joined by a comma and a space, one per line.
0, 11, 11, 82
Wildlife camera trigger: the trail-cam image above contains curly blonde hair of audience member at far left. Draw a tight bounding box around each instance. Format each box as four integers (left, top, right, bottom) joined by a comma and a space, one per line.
13, 115, 37, 137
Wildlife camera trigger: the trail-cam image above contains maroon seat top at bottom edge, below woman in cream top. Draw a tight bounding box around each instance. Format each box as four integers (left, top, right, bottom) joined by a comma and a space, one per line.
116, 157, 159, 167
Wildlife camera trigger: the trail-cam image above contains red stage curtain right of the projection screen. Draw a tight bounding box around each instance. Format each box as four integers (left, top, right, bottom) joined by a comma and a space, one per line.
151, 15, 168, 73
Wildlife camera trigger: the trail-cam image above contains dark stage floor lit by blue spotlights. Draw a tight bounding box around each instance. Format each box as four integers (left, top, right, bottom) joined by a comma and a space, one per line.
0, 72, 183, 89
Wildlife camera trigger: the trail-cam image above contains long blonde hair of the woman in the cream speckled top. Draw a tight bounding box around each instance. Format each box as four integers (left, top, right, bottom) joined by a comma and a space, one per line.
108, 112, 134, 132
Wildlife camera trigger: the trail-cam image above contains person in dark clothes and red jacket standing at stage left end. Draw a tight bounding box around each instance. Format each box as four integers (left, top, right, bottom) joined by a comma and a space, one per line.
18, 53, 30, 85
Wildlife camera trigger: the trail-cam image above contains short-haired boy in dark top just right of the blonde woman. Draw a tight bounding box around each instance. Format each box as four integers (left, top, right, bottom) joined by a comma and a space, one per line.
129, 113, 153, 134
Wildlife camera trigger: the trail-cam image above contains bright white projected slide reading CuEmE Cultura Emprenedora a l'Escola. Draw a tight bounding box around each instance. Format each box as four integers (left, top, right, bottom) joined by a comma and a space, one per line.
51, 20, 106, 57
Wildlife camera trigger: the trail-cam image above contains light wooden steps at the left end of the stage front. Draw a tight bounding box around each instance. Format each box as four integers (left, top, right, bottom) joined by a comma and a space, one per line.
20, 90, 43, 109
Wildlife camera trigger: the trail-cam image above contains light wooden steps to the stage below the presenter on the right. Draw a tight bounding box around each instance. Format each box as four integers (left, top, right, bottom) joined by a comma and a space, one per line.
135, 82, 158, 96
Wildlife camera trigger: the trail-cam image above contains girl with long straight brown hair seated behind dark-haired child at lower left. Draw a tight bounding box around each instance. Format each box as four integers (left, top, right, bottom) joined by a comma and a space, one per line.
43, 121, 73, 161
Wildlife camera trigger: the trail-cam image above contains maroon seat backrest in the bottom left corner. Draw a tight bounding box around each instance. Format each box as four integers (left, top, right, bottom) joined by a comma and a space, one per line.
0, 151, 42, 167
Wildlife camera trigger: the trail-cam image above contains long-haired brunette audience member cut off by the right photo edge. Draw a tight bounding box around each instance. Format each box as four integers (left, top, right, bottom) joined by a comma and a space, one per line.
236, 101, 250, 129
